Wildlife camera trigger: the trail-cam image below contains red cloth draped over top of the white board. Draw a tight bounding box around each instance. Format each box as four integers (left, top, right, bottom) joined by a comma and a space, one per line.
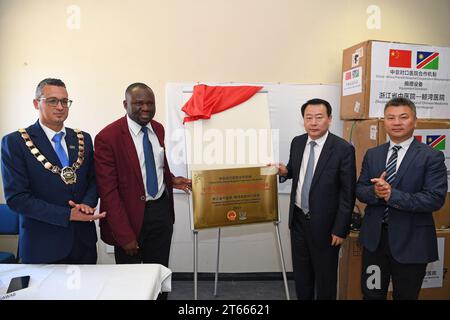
181, 84, 263, 123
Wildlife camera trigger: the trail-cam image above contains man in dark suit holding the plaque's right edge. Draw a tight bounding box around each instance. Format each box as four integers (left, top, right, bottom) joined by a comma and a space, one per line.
278, 99, 356, 300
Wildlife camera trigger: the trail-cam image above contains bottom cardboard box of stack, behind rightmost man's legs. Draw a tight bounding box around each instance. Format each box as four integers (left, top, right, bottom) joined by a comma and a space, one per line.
338, 229, 450, 300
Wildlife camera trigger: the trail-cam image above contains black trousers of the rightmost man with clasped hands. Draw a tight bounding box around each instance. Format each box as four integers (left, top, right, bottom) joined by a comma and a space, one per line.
361, 225, 427, 300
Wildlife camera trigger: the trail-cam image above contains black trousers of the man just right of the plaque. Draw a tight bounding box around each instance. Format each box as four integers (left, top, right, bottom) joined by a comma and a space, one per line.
291, 207, 340, 300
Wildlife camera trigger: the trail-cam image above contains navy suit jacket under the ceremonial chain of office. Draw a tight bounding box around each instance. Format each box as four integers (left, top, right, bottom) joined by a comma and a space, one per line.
1, 122, 98, 263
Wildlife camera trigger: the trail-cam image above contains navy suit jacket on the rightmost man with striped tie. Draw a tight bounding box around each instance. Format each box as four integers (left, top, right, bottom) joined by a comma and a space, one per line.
356, 139, 447, 263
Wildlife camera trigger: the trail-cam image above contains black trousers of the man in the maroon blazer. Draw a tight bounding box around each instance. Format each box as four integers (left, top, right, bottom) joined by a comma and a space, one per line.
114, 193, 173, 300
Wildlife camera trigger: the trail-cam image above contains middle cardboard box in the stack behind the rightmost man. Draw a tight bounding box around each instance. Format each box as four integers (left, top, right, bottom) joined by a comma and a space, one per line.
343, 119, 450, 229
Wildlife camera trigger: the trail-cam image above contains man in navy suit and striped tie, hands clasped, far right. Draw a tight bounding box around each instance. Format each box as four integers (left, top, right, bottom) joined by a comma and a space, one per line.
356, 98, 447, 300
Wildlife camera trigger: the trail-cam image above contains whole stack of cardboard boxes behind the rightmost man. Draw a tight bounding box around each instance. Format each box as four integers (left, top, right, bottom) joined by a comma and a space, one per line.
338, 41, 450, 299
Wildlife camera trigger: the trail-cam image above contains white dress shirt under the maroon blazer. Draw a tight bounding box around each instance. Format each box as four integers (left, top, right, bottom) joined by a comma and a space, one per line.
127, 115, 165, 201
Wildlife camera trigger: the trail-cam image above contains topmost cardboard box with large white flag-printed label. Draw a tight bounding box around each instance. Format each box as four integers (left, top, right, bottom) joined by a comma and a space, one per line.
340, 40, 450, 120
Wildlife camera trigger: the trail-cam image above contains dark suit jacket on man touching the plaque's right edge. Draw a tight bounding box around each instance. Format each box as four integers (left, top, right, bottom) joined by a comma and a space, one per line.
280, 132, 356, 247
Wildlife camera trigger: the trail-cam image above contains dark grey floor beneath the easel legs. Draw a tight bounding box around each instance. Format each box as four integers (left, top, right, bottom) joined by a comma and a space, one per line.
168, 280, 296, 300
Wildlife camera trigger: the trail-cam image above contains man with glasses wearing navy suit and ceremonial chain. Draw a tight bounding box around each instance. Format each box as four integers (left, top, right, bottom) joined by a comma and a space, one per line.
1, 78, 106, 264
